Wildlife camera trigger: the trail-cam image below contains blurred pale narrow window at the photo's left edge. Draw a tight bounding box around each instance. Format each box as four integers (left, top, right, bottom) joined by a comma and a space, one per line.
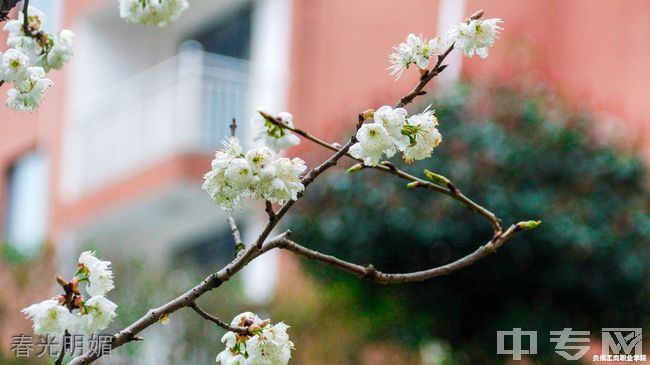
6, 152, 48, 256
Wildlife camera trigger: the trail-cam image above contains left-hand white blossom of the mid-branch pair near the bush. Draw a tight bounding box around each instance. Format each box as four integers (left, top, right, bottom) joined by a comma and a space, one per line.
350, 123, 396, 166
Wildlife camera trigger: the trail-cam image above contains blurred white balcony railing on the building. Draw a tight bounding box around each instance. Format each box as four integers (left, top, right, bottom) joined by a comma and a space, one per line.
63, 50, 250, 198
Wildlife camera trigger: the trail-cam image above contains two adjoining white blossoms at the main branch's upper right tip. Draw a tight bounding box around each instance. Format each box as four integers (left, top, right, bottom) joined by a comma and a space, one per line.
388, 18, 502, 78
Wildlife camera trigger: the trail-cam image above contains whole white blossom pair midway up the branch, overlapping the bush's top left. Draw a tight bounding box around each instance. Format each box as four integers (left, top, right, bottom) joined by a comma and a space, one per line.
350, 105, 442, 166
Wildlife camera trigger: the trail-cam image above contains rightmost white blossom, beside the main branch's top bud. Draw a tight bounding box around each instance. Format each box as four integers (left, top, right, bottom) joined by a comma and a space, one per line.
448, 18, 503, 58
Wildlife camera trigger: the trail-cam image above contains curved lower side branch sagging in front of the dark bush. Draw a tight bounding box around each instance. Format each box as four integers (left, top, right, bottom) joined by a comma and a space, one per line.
273, 222, 534, 284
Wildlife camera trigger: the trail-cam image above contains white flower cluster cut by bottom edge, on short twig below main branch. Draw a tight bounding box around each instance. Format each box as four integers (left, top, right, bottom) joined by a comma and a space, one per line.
217, 312, 294, 365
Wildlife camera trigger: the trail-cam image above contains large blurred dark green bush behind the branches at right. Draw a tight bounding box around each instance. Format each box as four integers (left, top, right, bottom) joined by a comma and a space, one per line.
288, 86, 650, 364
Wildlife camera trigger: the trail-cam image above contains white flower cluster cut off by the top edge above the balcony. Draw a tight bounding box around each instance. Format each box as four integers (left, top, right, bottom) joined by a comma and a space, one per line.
120, 0, 189, 27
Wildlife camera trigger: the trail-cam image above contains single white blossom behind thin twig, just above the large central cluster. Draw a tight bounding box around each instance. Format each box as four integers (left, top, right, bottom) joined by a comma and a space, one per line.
251, 109, 300, 153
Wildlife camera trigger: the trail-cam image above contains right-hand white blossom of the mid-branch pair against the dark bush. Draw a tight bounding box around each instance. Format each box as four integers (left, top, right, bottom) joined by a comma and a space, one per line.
402, 110, 442, 163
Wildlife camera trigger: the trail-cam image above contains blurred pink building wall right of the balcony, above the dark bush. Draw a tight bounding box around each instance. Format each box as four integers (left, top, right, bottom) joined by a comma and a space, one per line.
290, 0, 650, 158
